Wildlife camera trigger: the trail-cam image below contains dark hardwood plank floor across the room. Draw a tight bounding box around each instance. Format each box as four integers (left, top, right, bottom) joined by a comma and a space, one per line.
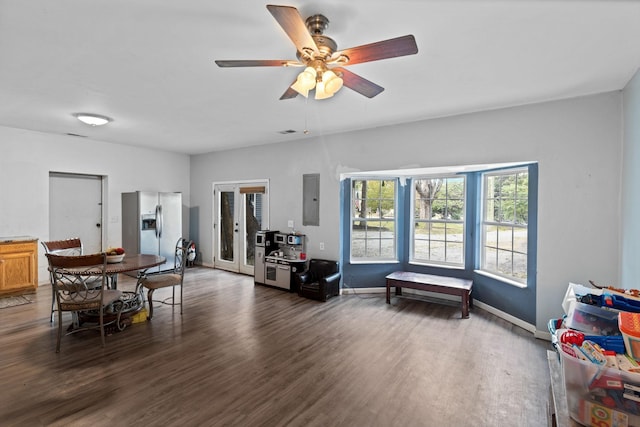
0, 267, 551, 426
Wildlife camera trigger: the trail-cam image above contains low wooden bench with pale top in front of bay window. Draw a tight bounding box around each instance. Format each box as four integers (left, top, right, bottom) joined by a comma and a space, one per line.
387, 271, 473, 319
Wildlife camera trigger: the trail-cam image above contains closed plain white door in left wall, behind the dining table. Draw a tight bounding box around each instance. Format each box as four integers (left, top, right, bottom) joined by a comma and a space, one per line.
49, 172, 103, 254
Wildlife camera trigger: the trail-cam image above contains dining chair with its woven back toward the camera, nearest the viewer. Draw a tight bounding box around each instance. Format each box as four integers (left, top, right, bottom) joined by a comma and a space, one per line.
46, 253, 123, 353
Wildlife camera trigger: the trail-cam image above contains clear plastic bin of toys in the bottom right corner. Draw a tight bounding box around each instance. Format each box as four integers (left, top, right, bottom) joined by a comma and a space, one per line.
558, 348, 640, 427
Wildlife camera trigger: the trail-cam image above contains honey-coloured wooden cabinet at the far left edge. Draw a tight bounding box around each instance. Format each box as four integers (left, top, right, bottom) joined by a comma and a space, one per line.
0, 237, 38, 295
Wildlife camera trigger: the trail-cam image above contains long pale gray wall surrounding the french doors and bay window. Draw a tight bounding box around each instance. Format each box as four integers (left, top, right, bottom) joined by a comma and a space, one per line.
191, 92, 622, 331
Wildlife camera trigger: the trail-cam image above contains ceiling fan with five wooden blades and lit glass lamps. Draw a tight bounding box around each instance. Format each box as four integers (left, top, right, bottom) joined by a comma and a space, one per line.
215, 5, 418, 99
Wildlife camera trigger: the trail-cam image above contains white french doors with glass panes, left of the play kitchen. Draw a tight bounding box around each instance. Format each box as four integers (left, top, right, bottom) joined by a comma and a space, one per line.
213, 181, 269, 275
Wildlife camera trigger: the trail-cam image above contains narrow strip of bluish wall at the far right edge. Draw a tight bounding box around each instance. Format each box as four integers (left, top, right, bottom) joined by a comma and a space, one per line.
620, 71, 640, 288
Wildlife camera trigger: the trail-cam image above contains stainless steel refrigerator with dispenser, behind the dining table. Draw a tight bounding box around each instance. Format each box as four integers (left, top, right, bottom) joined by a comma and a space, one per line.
122, 191, 182, 272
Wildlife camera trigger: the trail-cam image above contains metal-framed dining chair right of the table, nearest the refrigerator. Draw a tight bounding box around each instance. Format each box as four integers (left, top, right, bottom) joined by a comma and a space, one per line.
140, 237, 193, 320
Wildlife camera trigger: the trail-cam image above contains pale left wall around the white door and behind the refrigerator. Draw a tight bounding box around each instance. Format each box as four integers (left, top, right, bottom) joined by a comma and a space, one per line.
0, 127, 190, 283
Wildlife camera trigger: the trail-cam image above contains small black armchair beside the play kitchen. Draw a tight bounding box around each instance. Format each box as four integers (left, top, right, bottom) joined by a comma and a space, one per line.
294, 259, 340, 301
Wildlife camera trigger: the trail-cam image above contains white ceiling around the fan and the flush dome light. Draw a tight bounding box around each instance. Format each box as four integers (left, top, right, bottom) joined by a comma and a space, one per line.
0, 0, 640, 154
